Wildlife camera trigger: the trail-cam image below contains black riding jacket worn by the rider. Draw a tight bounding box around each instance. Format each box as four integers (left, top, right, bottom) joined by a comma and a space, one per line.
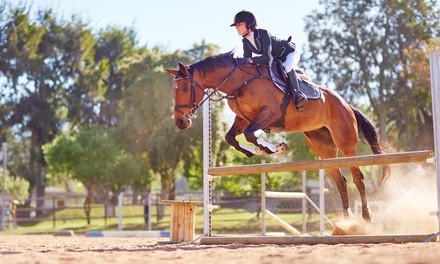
243, 29, 295, 64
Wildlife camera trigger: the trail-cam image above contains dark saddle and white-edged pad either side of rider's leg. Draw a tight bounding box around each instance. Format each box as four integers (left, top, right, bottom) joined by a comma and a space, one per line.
269, 60, 321, 100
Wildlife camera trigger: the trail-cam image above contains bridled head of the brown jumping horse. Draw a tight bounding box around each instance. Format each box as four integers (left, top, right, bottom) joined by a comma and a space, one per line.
164, 63, 205, 129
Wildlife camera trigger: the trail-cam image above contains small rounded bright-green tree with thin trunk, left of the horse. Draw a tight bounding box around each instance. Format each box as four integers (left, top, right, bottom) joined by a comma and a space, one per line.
44, 126, 147, 224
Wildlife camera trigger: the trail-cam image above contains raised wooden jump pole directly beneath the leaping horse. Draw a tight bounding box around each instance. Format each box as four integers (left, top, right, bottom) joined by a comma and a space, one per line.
208, 150, 433, 176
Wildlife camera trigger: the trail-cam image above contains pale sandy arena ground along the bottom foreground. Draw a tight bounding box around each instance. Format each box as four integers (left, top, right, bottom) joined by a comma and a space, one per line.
0, 235, 440, 264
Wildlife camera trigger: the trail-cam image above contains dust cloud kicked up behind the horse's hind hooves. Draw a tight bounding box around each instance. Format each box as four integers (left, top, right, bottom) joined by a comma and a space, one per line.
372, 164, 439, 234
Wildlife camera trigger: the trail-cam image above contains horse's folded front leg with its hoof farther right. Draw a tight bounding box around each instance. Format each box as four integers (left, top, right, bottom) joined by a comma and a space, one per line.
243, 108, 290, 154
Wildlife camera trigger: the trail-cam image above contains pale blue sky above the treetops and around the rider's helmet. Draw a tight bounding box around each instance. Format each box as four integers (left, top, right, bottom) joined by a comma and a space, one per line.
25, 0, 319, 56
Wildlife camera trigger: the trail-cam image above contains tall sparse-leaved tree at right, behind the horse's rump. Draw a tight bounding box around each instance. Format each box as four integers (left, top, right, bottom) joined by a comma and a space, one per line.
304, 0, 440, 148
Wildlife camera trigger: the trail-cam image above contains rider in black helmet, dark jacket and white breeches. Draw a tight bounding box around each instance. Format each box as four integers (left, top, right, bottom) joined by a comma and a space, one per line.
231, 10, 307, 112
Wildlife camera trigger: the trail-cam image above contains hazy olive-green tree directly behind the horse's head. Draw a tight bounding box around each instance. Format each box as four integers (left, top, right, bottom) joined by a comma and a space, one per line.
119, 41, 230, 217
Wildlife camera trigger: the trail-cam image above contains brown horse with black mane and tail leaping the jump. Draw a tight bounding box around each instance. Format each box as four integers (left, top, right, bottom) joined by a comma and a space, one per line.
165, 53, 390, 221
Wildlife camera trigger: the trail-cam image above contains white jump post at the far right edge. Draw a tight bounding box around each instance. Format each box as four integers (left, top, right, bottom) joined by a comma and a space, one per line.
429, 51, 440, 238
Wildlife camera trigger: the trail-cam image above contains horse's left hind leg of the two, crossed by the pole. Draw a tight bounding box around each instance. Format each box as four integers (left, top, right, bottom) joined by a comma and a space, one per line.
304, 128, 352, 217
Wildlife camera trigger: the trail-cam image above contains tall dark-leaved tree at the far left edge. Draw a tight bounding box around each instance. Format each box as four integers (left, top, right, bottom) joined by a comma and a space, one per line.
0, 3, 102, 213
